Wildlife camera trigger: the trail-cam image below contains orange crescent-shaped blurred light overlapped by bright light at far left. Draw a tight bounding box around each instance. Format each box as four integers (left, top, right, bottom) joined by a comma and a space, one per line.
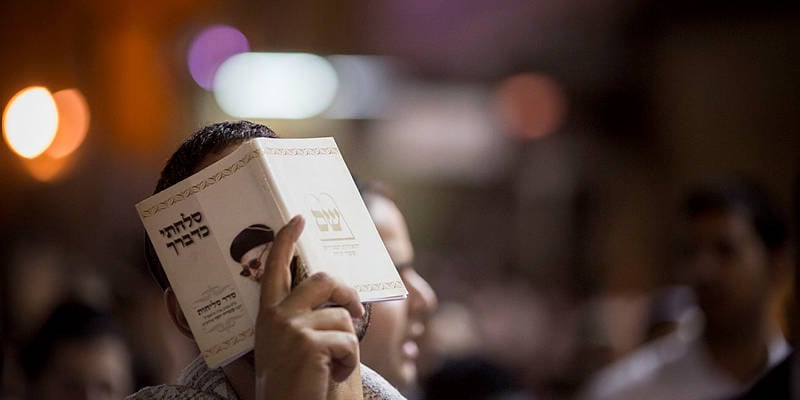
45, 89, 89, 158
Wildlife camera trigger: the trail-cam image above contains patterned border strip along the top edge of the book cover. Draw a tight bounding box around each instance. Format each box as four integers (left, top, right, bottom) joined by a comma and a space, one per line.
142, 147, 339, 218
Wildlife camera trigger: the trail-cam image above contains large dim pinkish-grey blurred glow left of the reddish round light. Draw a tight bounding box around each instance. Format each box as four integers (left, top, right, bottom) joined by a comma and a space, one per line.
363, 84, 512, 184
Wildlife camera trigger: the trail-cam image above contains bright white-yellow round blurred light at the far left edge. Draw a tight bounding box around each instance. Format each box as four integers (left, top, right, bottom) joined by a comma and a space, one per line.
3, 86, 58, 158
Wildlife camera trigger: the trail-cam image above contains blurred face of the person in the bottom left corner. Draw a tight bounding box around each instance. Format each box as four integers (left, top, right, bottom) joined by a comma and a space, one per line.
31, 337, 133, 400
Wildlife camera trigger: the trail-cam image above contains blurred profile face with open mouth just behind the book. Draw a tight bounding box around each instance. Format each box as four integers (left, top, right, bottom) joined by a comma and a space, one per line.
361, 193, 436, 391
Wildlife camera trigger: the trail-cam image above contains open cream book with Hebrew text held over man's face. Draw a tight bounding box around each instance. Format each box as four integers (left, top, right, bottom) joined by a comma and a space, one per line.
136, 137, 407, 368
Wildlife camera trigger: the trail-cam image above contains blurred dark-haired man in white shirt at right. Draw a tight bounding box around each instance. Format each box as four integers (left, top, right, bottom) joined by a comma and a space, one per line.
584, 181, 791, 400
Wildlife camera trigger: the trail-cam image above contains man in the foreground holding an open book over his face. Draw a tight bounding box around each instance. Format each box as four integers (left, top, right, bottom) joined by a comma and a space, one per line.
130, 121, 404, 400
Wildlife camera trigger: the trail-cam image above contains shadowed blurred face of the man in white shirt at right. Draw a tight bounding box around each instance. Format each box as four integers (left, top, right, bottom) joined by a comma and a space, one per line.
687, 209, 771, 334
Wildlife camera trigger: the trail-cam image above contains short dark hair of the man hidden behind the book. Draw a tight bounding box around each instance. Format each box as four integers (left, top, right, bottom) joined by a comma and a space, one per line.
144, 121, 278, 289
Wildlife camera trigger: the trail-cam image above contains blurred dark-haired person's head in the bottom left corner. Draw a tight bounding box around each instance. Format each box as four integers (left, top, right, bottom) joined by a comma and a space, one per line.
21, 301, 133, 400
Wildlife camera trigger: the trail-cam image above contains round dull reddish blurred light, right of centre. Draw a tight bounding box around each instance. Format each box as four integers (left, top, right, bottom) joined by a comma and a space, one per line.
494, 73, 566, 139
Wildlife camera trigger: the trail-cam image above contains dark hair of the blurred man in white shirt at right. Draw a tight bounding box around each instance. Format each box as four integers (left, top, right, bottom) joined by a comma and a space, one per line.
684, 179, 789, 251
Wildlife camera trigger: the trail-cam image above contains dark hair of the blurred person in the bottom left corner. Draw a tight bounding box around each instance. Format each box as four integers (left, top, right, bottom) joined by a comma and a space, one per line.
20, 301, 127, 381
